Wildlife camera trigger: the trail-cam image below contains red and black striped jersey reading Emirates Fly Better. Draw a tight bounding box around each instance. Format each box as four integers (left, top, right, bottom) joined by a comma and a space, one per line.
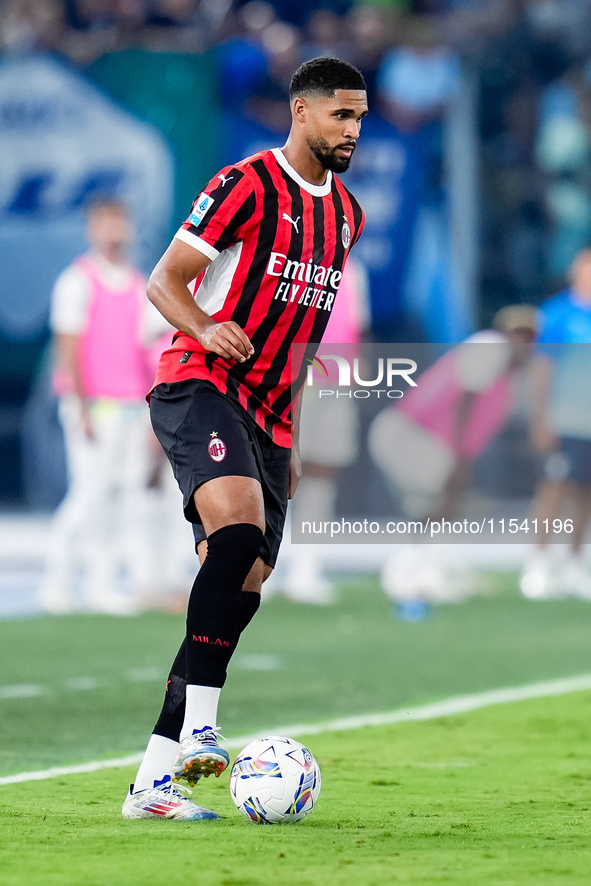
154, 148, 364, 446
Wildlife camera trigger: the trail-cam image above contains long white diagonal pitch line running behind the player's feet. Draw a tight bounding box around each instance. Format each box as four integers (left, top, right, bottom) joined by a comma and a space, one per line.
0, 674, 591, 785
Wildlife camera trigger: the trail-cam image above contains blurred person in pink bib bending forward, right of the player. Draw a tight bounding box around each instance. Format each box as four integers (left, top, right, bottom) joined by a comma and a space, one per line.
368, 305, 537, 620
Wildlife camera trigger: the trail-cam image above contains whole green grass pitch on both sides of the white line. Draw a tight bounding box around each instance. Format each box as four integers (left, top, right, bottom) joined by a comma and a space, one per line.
0, 575, 591, 886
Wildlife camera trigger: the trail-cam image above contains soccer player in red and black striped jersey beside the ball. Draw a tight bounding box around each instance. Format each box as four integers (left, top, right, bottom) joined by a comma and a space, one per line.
123, 58, 367, 819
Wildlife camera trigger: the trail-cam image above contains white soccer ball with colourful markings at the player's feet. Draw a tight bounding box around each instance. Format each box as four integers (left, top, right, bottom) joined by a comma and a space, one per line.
230, 735, 320, 824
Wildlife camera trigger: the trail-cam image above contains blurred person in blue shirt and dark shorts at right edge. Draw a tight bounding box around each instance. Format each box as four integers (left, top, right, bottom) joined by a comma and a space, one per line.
520, 249, 591, 600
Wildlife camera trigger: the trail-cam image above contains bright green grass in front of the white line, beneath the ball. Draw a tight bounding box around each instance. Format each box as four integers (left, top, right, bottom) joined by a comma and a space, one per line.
0, 693, 591, 886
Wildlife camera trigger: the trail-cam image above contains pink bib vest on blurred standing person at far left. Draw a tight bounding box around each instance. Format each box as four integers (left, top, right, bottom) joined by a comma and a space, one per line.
75, 256, 150, 401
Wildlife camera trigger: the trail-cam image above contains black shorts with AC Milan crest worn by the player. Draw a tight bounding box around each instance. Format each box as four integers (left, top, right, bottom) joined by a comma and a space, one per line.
150, 379, 291, 566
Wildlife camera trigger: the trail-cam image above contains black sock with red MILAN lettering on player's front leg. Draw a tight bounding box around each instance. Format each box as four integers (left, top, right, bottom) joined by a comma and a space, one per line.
186, 523, 263, 687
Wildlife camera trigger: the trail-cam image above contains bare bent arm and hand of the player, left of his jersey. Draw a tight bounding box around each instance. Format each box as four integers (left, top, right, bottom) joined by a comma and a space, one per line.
147, 239, 254, 363
